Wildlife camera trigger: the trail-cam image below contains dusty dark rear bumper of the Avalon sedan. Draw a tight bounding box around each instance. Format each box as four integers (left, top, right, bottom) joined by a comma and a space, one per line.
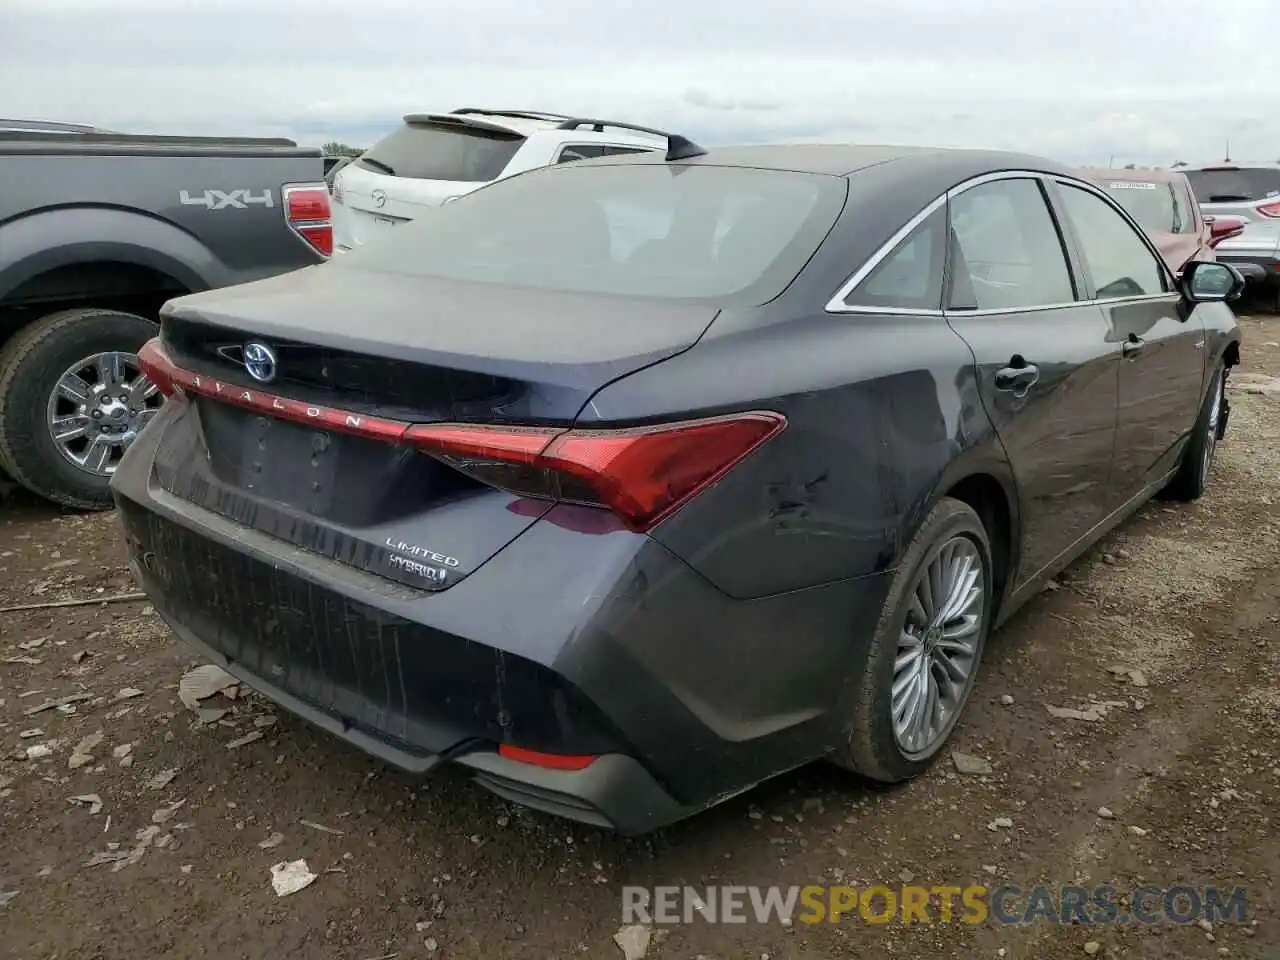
113, 416, 884, 833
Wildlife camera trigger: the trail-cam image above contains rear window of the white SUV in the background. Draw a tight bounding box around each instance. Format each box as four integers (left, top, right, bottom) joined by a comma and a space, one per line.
356, 123, 525, 183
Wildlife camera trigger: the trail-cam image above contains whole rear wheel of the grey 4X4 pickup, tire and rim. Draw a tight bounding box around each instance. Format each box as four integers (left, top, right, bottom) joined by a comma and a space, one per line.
0, 307, 164, 509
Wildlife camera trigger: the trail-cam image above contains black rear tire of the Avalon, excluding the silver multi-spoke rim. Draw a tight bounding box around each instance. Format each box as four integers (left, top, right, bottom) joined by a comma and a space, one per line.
831, 498, 995, 783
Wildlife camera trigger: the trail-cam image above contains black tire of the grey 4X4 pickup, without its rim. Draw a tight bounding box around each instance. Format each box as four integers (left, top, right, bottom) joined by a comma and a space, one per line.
0, 307, 159, 511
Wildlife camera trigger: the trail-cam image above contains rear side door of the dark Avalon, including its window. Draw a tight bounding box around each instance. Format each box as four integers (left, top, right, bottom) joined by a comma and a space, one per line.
945, 174, 1120, 585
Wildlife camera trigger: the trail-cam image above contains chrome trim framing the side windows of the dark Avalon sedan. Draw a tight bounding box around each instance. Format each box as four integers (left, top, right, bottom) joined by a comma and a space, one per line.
824, 170, 1181, 316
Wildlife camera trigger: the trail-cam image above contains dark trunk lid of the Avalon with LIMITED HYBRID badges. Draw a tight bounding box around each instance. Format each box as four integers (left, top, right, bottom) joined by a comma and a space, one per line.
156, 265, 716, 590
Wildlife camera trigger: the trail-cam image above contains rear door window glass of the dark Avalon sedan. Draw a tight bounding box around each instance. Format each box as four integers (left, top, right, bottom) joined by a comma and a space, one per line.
947, 178, 1075, 310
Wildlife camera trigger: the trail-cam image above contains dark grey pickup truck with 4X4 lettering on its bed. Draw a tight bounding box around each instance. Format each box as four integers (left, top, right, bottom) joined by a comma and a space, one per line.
0, 120, 333, 509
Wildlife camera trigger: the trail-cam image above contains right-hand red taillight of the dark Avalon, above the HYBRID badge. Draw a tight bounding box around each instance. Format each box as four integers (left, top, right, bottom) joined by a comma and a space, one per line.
404, 412, 786, 531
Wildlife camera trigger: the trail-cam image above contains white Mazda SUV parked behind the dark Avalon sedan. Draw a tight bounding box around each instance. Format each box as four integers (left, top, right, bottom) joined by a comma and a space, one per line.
333, 108, 669, 252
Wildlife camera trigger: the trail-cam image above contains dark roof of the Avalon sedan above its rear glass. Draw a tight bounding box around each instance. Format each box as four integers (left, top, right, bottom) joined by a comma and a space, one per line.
579, 143, 1079, 183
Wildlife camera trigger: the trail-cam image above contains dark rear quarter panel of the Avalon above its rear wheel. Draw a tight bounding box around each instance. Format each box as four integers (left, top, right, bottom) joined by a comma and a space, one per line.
580, 314, 1011, 599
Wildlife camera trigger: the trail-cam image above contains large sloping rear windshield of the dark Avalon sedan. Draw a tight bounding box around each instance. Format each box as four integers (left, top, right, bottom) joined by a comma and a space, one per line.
334, 163, 846, 303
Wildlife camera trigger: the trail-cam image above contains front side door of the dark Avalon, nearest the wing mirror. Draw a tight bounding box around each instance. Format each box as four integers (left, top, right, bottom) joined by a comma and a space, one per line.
1055, 180, 1206, 506
